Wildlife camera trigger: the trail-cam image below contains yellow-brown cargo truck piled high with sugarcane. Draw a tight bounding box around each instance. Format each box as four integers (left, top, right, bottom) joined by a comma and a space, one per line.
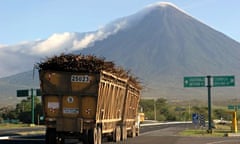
39, 55, 141, 144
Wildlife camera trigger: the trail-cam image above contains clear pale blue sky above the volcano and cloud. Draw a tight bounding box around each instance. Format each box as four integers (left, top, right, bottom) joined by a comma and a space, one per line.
0, 0, 240, 46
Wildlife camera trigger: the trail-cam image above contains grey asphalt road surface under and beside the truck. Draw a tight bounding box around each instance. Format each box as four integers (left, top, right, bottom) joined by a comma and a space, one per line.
0, 124, 240, 144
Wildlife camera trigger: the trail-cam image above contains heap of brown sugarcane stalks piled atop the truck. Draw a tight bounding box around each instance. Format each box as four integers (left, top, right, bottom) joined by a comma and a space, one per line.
37, 54, 141, 88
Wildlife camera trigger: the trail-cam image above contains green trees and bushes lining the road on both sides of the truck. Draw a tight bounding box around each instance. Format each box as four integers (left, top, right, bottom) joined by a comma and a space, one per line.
0, 97, 236, 124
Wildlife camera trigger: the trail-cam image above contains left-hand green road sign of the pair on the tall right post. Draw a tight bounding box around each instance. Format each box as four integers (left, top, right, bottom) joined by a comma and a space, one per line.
183, 76, 205, 87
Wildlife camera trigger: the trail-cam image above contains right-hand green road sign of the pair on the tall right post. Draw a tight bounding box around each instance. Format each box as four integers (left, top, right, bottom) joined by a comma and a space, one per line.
213, 76, 235, 87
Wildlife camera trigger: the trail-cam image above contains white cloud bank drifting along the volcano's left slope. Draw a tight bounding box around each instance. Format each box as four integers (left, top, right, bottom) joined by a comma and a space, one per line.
0, 19, 127, 77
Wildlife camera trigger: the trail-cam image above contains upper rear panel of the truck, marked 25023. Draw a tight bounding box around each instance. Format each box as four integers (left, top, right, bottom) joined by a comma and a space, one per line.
40, 71, 99, 95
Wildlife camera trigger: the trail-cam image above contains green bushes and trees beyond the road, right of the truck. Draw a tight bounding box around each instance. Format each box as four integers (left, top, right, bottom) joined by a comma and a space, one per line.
140, 98, 232, 121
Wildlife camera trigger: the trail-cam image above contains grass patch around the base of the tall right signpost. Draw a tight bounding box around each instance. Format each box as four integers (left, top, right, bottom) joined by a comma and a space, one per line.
179, 125, 234, 137
